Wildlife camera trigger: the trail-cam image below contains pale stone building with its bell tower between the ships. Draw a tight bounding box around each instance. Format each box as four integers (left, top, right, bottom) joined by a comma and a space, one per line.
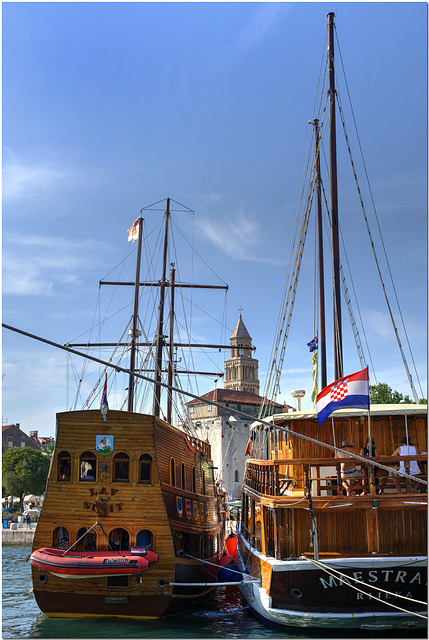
187, 314, 290, 500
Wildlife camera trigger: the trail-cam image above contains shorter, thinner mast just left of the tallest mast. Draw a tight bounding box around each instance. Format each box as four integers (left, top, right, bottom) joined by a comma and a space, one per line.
313, 119, 327, 389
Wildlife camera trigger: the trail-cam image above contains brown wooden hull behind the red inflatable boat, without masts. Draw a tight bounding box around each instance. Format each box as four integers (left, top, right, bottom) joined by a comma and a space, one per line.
32, 411, 225, 618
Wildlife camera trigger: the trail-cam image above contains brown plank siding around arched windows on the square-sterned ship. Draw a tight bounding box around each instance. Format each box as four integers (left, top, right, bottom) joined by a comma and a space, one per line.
32, 410, 223, 617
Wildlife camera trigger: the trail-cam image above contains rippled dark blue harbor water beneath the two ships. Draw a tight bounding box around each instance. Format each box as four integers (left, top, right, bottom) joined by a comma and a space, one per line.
2, 546, 426, 638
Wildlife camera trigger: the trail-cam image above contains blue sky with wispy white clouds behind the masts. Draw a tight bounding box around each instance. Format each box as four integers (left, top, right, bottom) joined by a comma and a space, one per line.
2, 2, 427, 436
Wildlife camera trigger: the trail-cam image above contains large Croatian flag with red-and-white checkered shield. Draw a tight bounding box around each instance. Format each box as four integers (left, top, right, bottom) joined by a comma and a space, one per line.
316, 367, 369, 424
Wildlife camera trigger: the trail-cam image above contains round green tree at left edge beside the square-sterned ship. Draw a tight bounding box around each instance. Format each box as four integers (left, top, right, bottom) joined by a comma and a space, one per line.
2, 447, 50, 511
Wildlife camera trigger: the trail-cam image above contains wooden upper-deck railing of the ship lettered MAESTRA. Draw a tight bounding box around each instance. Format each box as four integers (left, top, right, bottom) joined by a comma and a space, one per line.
245, 454, 427, 496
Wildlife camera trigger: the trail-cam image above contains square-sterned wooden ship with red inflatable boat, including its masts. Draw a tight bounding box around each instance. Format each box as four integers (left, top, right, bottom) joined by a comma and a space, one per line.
30, 199, 229, 619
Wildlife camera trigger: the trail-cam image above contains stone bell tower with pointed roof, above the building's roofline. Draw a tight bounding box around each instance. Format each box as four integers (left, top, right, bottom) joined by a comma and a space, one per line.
224, 313, 259, 395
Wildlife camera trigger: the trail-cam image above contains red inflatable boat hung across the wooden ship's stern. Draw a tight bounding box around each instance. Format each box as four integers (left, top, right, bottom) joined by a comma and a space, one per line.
30, 547, 158, 578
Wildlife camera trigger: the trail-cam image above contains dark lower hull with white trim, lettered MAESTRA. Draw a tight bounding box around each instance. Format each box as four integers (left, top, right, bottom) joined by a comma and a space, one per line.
239, 541, 427, 630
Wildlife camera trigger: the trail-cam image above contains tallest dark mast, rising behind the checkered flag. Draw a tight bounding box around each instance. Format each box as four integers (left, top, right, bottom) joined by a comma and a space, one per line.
328, 13, 343, 380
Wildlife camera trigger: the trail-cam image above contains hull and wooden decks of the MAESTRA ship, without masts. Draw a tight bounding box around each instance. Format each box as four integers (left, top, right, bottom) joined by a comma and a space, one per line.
238, 406, 427, 630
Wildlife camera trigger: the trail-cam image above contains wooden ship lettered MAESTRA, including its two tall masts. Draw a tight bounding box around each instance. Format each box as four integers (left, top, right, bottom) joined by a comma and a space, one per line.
238, 13, 427, 632
